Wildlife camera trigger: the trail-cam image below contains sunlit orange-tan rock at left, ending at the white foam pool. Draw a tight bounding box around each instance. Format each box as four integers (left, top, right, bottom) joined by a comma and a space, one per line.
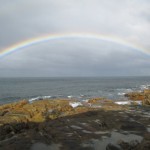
0, 99, 79, 124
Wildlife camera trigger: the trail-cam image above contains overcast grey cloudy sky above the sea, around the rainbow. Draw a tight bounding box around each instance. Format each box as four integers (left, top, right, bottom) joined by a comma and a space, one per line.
0, 0, 150, 77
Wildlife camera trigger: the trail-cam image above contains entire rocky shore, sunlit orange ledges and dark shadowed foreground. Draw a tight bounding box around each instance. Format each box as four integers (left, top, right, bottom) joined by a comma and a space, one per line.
0, 90, 150, 150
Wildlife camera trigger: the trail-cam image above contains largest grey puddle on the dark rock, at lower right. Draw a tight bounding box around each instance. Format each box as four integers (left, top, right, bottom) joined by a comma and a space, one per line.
82, 132, 143, 150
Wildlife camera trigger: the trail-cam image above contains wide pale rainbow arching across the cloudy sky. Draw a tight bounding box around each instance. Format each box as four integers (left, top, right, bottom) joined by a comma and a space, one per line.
0, 33, 150, 58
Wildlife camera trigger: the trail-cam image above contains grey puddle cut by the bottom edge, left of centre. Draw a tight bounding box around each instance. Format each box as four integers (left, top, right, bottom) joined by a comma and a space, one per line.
30, 143, 61, 150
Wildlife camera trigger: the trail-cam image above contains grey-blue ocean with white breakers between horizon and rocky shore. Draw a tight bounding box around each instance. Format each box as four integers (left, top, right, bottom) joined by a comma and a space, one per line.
0, 77, 150, 104
